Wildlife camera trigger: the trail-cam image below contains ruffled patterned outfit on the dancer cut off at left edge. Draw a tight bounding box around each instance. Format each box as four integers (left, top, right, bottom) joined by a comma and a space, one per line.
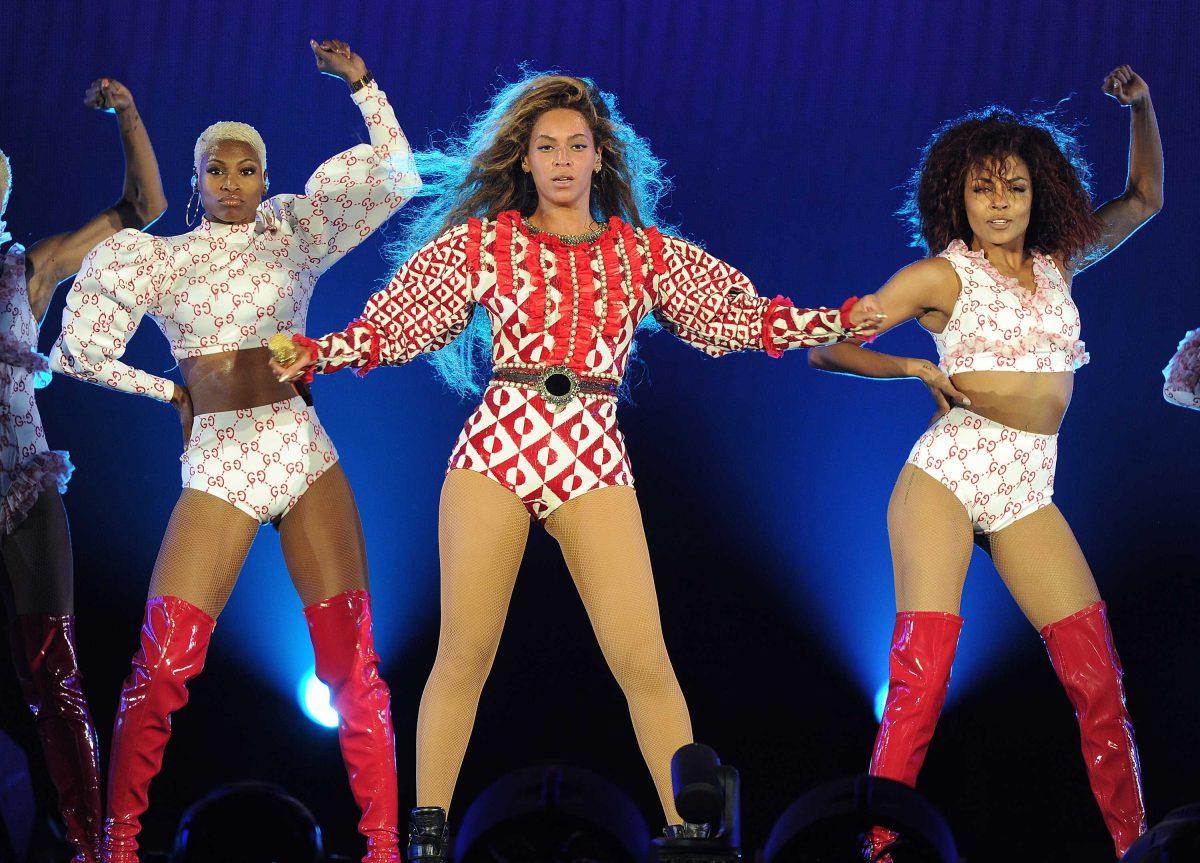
0, 242, 73, 535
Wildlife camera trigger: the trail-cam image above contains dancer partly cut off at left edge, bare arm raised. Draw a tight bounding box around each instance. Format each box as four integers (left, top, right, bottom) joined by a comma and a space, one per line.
0, 78, 167, 863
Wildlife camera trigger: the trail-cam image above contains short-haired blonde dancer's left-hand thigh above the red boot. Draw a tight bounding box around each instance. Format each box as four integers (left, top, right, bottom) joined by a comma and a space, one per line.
150, 489, 258, 618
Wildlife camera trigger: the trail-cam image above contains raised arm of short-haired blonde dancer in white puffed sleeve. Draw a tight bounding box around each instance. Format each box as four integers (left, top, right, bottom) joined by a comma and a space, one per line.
266, 40, 421, 271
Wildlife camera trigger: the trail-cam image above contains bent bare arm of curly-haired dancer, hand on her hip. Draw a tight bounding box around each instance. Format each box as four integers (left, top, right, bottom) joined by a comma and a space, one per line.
809, 258, 971, 414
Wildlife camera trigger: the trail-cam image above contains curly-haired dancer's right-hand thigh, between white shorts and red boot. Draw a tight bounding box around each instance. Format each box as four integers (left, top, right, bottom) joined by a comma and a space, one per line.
989, 504, 1100, 630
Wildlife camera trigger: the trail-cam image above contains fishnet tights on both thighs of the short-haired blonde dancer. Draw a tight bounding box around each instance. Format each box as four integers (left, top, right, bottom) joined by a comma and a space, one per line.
149, 465, 367, 618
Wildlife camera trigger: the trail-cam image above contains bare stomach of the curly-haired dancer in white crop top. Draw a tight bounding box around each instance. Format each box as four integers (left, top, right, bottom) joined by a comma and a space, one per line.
950, 372, 1075, 435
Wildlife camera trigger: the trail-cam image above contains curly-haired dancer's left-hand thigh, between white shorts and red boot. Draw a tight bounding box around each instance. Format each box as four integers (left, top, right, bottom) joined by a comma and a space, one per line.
888, 465, 974, 615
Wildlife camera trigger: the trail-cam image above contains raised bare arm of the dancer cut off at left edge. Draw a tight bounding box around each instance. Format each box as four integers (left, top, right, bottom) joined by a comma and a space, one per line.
25, 78, 167, 320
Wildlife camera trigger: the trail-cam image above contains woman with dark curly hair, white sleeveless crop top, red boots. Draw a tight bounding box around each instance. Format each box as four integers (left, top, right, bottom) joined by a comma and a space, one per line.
810, 66, 1163, 856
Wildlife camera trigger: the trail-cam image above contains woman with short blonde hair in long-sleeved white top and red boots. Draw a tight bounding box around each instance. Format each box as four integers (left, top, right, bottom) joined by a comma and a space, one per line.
52, 42, 420, 863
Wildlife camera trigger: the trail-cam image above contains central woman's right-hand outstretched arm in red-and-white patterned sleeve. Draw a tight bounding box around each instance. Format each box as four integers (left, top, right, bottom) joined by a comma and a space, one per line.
647, 228, 881, 356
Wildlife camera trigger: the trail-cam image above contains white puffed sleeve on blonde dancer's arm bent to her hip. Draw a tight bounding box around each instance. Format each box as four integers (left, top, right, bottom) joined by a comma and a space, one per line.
50, 228, 175, 402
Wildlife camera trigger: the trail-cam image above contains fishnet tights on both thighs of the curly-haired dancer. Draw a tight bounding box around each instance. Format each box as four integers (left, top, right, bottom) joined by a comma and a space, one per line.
888, 465, 1100, 630
